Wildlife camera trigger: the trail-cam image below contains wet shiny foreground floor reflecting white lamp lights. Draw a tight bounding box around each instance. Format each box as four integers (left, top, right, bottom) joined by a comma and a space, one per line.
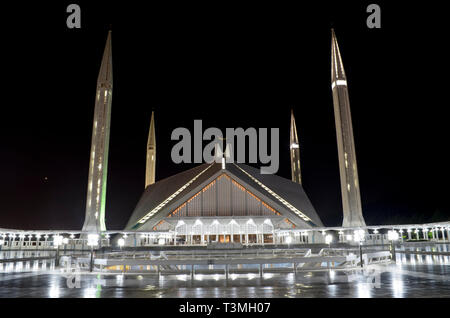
0, 248, 450, 298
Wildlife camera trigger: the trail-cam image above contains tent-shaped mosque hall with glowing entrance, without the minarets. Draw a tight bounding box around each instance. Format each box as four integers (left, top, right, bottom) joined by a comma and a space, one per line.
125, 157, 323, 245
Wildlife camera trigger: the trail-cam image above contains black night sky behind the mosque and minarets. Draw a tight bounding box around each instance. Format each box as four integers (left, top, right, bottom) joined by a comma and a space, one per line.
0, 1, 450, 229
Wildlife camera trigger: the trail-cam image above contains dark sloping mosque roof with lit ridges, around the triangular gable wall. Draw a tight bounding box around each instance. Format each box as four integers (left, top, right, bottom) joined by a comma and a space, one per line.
125, 163, 323, 230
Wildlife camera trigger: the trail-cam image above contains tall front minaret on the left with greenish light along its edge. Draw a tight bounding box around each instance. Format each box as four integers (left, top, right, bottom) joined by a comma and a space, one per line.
83, 31, 113, 233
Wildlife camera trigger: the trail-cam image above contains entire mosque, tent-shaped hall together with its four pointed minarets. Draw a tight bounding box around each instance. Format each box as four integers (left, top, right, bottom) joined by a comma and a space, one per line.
83, 30, 365, 246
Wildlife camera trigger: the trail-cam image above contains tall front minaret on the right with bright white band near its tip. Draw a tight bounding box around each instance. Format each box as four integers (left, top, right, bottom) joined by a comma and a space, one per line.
331, 29, 366, 227
